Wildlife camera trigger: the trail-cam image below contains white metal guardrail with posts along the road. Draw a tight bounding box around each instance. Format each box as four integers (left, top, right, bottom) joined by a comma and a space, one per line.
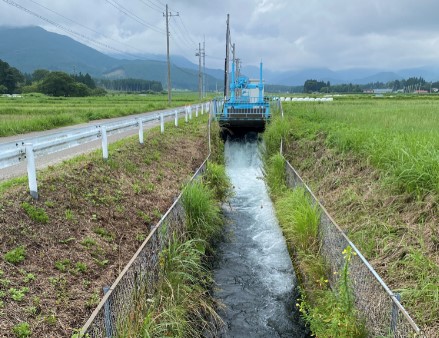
0, 102, 211, 199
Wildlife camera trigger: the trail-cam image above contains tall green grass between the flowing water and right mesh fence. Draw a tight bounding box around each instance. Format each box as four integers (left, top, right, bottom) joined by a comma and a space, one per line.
265, 141, 367, 338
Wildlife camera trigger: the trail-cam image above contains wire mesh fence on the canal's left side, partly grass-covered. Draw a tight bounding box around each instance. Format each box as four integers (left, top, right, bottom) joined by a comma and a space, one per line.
79, 159, 208, 338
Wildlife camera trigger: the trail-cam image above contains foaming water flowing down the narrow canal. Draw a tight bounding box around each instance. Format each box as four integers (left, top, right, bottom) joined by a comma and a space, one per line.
214, 137, 308, 338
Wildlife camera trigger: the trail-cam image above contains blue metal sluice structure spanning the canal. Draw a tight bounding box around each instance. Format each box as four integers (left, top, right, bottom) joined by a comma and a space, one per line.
217, 62, 270, 129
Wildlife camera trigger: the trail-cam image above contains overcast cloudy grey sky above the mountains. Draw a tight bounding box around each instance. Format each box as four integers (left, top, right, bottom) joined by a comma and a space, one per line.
0, 0, 439, 70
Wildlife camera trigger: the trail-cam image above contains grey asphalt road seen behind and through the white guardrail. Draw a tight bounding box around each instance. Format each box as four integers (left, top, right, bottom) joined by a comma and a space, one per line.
0, 111, 180, 182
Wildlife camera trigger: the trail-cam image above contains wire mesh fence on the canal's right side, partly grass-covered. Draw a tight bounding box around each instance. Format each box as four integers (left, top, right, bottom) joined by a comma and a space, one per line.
286, 161, 425, 338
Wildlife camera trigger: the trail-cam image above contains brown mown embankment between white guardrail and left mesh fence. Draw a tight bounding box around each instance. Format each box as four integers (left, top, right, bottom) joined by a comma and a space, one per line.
0, 115, 213, 337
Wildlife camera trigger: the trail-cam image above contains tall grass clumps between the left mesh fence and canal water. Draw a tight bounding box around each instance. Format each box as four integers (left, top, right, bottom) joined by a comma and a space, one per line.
118, 162, 234, 338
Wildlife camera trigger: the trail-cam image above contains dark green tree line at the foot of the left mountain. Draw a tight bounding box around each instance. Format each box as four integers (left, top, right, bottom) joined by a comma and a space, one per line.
0, 60, 163, 97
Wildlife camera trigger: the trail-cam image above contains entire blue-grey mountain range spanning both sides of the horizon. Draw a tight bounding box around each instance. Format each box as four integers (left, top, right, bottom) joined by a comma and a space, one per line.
0, 27, 439, 90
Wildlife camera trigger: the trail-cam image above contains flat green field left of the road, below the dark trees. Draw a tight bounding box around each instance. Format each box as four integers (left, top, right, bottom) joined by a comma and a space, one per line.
0, 93, 204, 137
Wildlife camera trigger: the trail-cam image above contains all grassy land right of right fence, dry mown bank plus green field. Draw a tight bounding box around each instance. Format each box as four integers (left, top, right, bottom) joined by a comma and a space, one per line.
267, 96, 439, 337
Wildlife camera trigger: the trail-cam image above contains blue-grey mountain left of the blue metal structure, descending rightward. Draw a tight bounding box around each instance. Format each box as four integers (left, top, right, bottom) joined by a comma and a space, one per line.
0, 27, 223, 90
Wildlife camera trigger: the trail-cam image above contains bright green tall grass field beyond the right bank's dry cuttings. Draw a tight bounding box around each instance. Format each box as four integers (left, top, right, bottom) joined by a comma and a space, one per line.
284, 97, 439, 196
